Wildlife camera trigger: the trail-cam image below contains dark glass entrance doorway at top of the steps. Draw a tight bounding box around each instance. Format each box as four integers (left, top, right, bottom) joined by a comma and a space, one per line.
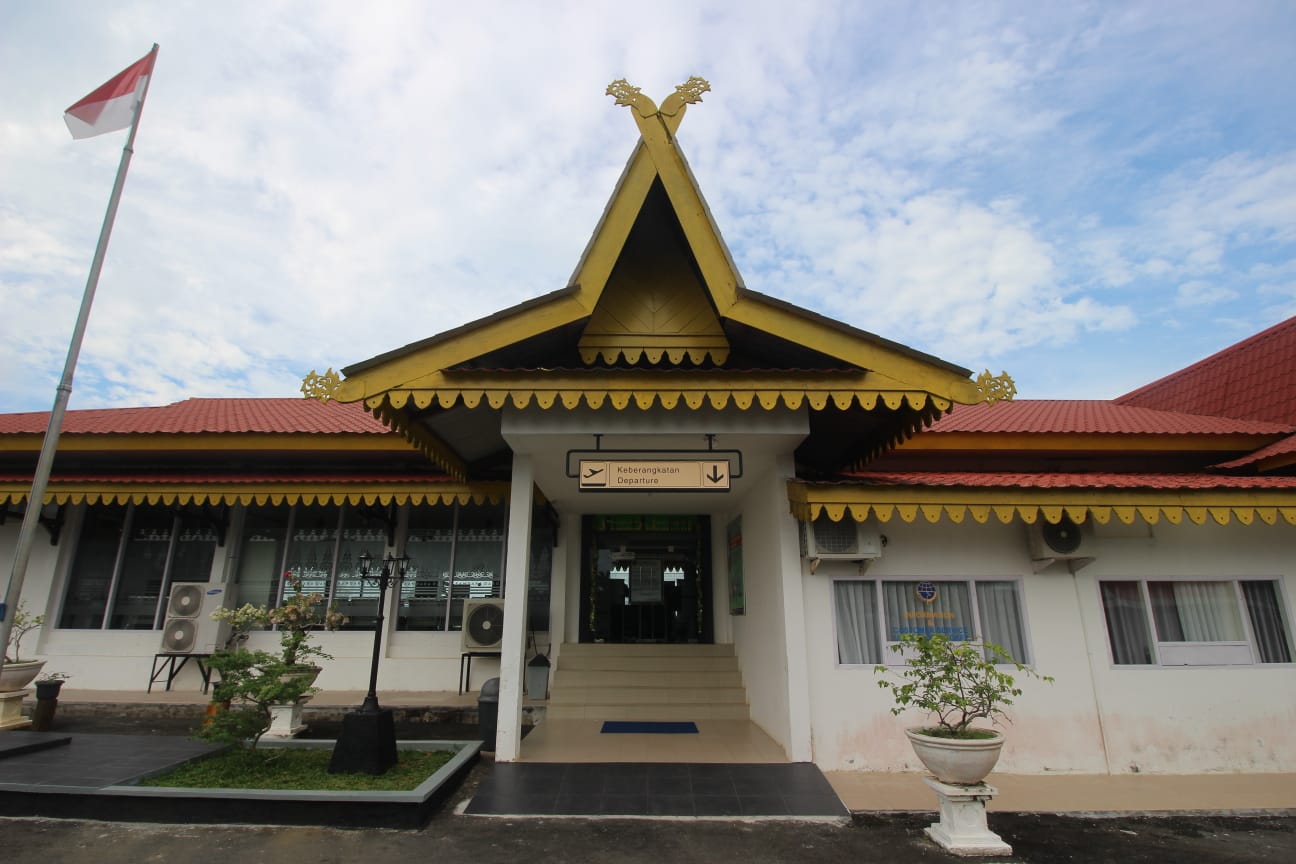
581, 516, 714, 644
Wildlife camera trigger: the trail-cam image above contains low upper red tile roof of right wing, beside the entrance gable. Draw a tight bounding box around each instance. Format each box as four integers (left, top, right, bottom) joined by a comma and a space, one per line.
923, 399, 1296, 435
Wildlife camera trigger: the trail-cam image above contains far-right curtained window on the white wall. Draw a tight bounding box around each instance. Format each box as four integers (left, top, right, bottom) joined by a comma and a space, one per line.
1099, 579, 1292, 666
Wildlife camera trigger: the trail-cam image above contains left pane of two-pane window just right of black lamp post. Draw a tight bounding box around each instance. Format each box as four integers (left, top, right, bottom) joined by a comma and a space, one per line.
397, 505, 455, 630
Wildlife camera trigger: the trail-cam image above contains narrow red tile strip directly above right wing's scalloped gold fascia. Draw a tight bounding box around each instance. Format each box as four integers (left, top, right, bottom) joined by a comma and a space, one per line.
848, 472, 1296, 490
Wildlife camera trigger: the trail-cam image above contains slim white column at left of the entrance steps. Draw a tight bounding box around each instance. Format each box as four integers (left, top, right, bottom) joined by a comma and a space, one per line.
495, 453, 535, 762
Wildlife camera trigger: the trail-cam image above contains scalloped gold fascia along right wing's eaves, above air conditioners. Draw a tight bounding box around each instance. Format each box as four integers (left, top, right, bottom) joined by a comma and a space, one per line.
788, 482, 1296, 525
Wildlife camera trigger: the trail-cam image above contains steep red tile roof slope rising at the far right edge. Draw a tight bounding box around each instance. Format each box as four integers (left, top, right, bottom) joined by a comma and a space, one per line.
1115, 317, 1296, 424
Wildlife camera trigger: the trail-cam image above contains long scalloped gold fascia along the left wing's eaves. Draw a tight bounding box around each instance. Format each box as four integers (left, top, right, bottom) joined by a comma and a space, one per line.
0, 482, 508, 505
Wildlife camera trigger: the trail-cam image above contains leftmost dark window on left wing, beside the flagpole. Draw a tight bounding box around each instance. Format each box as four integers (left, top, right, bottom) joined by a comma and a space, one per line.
58, 504, 218, 630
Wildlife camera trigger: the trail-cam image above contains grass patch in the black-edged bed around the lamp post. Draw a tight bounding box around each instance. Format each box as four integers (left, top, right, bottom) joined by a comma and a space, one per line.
140, 747, 455, 791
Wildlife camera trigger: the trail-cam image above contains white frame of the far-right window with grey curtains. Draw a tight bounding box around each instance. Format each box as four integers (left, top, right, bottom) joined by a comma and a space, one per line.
1094, 574, 1296, 670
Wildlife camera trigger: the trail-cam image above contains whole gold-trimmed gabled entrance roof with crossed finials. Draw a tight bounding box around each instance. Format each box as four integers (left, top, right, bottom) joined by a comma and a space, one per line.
313, 78, 1011, 477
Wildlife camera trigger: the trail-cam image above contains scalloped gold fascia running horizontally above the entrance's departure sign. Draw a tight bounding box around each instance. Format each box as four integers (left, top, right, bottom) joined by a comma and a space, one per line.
364, 386, 950, 414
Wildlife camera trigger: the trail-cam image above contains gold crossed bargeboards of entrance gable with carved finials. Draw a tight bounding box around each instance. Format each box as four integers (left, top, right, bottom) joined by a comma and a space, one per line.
321, 79, 990, 411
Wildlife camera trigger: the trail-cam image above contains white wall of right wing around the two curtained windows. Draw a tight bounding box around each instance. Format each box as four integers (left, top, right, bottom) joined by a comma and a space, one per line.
804, 518, 1296, 773
